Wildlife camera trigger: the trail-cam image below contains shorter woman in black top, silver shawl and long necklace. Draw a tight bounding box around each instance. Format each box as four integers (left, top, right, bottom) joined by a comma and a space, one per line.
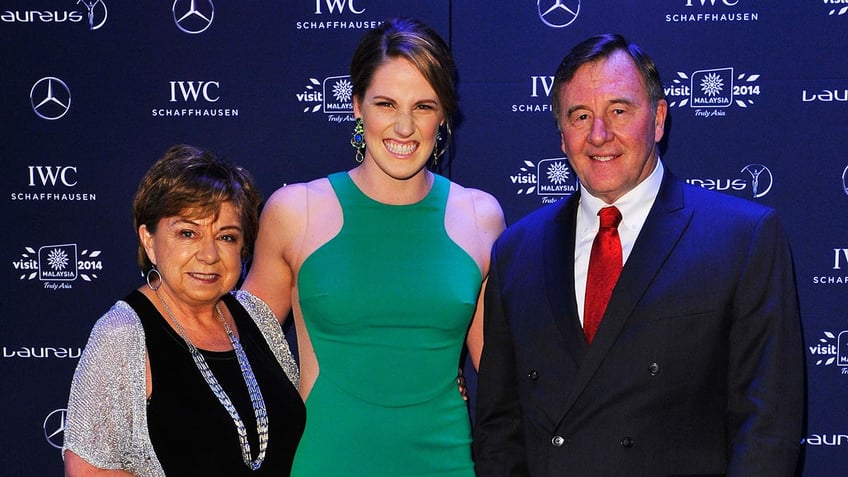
64, 146, 305, 477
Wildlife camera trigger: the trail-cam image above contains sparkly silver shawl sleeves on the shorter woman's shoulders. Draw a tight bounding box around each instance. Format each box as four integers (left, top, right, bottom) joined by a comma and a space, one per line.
63, 290, 300, 477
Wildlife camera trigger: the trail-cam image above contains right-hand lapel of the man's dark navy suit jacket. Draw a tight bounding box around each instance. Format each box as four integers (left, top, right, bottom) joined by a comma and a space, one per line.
563, 170, 692, 419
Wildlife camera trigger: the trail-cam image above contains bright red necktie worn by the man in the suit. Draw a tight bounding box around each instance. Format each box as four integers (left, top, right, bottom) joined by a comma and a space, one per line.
583, 207, 622, 343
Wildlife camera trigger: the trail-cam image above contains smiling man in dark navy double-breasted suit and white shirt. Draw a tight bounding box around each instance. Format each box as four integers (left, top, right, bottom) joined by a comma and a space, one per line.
474, 35, 805, 477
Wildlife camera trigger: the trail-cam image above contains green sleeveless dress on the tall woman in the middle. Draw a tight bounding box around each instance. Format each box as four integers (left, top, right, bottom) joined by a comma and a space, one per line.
292, 172, 482, 477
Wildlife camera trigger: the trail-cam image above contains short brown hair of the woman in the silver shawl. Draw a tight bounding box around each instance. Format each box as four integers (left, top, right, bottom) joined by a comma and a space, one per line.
132, 144, 262, 272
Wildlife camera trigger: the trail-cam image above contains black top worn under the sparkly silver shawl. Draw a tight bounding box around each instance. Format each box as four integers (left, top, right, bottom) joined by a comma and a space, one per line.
124, 290, 306, 477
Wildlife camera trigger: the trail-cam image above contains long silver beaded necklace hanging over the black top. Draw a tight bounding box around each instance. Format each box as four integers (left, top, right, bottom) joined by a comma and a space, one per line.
156, 291, 268, 470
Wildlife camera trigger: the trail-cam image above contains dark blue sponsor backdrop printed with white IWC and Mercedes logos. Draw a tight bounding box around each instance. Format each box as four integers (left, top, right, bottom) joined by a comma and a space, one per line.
0, 0, 848, 477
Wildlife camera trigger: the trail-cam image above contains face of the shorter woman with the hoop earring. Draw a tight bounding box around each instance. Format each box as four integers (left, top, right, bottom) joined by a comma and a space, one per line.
139, 202, 244, 306
